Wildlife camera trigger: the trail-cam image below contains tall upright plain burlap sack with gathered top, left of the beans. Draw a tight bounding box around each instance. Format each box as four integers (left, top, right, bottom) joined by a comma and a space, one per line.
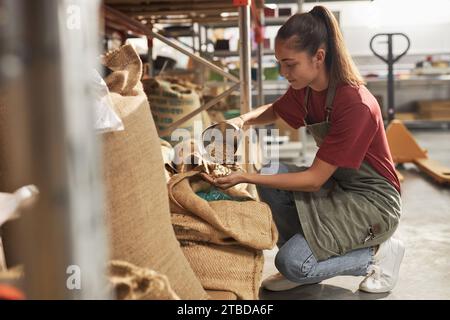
102, 45, 208, 299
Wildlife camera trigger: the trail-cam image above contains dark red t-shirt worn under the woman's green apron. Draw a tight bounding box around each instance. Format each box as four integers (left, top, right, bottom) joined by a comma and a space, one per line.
273, 85, 400, 192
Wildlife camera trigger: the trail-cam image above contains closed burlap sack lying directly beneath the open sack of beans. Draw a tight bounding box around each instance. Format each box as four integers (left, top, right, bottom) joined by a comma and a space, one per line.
182, 241, 264, 300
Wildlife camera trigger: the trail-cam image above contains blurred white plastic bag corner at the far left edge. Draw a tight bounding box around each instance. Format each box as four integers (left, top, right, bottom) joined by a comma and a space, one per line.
0, 185, 39, 226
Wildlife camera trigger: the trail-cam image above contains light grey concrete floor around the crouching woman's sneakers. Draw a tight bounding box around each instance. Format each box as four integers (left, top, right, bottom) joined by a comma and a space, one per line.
260, 131, 450, 300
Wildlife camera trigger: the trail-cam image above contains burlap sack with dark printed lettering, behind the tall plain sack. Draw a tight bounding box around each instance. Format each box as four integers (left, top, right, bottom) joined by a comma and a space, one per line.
142, 78, 203, 143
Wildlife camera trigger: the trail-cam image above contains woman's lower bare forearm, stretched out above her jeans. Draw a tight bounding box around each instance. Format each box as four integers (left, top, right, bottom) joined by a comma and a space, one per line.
243, 170, 321, 192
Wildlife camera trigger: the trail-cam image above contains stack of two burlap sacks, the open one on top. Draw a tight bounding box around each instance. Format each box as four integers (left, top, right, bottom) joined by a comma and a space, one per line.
168, 171, 278, 299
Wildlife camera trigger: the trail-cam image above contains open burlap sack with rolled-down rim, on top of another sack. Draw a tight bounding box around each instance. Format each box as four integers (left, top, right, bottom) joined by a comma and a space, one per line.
168, 172, 278, 250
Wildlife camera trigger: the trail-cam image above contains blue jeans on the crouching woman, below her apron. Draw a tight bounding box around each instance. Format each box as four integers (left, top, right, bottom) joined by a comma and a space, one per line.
256, 163, 374, 284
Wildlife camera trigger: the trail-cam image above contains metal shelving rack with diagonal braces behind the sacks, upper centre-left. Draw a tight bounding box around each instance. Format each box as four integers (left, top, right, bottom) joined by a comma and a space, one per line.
104, 0, 263, 169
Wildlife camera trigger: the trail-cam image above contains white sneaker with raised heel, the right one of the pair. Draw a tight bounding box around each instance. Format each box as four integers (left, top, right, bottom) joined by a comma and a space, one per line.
359, 238, 405, 293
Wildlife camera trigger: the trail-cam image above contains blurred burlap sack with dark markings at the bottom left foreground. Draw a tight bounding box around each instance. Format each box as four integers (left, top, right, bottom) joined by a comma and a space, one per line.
108, 260, 180, 300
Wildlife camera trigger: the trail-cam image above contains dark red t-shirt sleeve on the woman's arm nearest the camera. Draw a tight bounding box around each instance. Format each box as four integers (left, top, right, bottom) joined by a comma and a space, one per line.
317, 103, 378, 169
